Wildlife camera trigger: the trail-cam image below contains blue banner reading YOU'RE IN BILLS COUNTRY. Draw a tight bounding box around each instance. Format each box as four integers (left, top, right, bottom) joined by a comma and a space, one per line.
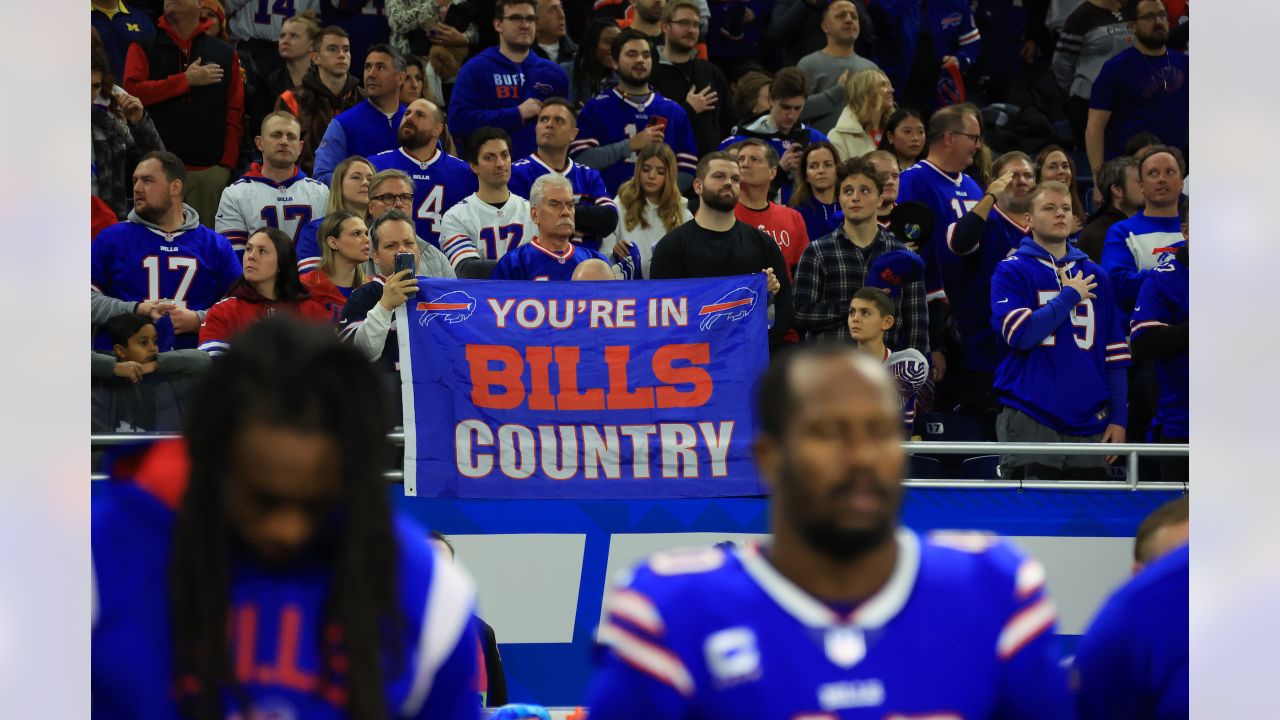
397, 273, 768, 498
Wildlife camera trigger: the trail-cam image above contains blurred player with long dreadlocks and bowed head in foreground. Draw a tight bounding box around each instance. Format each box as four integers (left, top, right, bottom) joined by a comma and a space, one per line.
92, 318, 479, 720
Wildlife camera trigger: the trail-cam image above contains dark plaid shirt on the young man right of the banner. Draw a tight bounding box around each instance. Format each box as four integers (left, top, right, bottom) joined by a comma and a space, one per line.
794, 225, 929, 356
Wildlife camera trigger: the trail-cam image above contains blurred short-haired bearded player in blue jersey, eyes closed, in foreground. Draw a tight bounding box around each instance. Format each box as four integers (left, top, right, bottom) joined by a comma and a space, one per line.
589, 346, 1073, 720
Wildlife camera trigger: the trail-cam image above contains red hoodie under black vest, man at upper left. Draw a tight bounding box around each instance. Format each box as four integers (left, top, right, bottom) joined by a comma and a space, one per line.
124, 17, 244, 170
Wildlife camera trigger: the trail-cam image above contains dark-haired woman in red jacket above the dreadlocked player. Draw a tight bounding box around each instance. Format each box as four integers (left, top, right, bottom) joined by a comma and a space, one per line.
200, 228, 333, 356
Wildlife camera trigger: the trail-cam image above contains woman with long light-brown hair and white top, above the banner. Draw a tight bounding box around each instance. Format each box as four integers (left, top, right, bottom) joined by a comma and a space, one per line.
600, 142, 694, 278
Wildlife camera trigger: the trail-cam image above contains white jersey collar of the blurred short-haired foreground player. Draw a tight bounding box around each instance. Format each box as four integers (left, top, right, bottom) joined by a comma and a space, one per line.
739, 528, 920, 629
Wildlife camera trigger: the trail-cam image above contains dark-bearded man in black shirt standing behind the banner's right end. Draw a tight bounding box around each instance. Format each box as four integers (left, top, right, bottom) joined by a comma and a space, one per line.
649, 151, 791, 348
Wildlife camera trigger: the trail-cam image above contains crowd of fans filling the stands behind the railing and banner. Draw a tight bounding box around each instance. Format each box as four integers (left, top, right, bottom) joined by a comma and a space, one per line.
91, 0, 1189, 479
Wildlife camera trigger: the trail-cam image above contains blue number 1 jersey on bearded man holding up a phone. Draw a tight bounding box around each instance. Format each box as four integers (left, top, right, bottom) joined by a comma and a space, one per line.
568, 87, 698, 197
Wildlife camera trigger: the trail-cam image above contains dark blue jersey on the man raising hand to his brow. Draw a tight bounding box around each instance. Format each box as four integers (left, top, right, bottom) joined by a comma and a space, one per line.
938, 206, 1029, 373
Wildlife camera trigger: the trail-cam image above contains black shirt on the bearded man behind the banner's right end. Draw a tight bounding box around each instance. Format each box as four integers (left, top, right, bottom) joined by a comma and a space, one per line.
649, 220, 791, 348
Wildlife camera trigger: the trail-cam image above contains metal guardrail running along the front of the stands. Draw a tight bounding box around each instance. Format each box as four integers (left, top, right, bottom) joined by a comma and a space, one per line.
90, 432, 1190, 491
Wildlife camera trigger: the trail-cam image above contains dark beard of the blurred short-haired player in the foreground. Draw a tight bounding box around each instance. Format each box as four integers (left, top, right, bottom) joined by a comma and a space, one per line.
781, 465, 901, 562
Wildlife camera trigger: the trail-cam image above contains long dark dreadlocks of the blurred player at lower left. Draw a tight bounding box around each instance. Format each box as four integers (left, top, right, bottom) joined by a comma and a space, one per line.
170, 318, 403, 720
